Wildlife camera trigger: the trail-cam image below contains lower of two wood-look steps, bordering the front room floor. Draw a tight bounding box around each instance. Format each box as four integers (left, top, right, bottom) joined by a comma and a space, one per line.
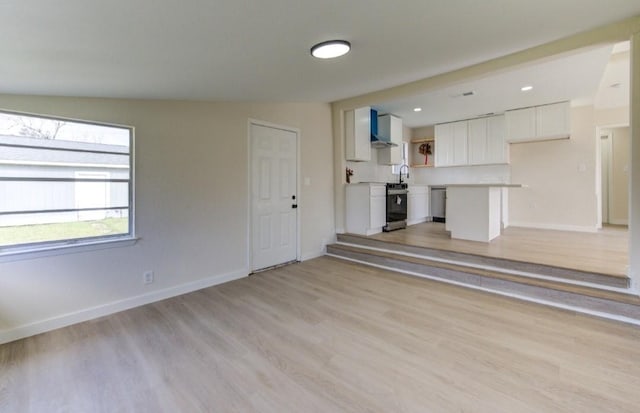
327, 238, 640, 324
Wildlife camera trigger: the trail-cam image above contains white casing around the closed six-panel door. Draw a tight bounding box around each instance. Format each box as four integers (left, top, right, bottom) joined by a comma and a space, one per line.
246, 118, 302, 274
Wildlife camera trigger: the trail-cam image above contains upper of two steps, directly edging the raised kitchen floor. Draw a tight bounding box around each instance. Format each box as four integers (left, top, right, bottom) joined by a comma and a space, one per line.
338, 234, 630, 289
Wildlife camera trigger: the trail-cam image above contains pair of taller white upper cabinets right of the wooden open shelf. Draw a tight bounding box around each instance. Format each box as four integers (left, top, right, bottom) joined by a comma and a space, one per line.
435, 116, 508, 167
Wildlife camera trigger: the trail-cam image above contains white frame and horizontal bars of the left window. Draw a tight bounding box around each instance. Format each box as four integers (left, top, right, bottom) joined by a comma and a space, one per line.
0, 108, 138, 262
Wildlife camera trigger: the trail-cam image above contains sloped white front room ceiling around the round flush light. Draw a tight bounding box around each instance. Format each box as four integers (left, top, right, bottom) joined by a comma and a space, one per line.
0, 0, 640, 102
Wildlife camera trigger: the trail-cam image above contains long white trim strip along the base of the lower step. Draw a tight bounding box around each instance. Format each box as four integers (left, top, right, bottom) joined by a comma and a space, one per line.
327, 254, 640, 326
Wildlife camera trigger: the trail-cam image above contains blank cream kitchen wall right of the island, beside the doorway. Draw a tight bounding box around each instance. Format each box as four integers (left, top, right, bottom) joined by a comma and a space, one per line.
509, 106, 598, 231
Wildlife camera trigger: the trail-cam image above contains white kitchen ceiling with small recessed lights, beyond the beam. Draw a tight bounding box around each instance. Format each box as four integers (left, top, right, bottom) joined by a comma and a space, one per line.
374, 45, 629, 127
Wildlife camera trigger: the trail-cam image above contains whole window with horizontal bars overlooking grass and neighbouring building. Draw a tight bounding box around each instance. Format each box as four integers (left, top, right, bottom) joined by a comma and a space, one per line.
0, 108, 133, 254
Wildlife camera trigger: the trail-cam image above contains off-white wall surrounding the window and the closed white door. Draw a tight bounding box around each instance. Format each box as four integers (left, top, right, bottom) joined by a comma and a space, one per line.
0, 95, 335, 342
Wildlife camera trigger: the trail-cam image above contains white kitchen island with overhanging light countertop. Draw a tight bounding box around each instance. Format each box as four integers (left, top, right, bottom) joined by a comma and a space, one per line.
444, 183, 523, 242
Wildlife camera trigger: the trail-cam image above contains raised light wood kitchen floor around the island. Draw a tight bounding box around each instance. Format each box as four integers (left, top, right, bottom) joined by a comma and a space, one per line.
364, 222, 629, 277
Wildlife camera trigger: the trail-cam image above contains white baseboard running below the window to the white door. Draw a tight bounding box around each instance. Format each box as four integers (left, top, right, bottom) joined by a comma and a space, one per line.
0, 269, 249, 344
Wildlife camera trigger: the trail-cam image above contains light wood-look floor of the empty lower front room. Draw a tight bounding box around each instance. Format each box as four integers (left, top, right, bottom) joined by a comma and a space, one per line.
0, 257, 640, 413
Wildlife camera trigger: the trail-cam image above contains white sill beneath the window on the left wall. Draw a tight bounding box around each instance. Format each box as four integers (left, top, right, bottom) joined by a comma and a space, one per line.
0, 237, 140, 263
